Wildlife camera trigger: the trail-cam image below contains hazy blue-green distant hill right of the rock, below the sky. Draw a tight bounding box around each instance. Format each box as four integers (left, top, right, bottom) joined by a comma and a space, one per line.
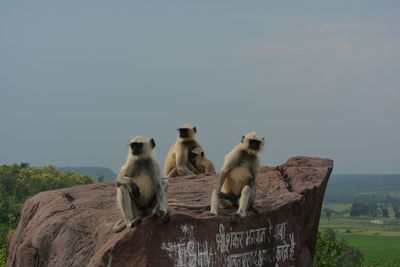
324, 174, 400, 203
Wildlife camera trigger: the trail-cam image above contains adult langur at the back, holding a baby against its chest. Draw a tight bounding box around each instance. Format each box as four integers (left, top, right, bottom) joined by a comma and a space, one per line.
164, 124, 212, 178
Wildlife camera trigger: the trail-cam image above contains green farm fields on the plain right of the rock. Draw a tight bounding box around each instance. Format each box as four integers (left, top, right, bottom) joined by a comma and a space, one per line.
319, 207, 400, 261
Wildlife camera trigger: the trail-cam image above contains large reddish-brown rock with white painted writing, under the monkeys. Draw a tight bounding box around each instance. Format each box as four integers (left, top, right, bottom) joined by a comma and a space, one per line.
7, 157, 333, 267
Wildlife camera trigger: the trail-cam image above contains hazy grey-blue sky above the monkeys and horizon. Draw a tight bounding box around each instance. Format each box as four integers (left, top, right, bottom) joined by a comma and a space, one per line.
0, 0, 400, 173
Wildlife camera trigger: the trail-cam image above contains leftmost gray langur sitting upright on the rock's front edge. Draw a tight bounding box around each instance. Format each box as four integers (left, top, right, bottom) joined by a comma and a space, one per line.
113, 136, 169, 232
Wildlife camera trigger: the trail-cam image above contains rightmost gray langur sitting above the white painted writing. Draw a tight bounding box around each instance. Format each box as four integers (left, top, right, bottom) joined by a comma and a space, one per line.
209, 132, 265, 223
